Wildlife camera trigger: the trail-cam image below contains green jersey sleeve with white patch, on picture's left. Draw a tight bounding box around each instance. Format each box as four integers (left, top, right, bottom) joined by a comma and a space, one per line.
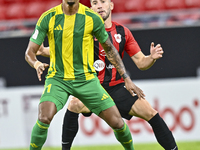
30, 15, 48, 45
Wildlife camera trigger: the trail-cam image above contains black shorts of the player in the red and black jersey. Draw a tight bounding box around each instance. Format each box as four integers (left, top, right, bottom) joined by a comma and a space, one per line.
83, 83, 138, 120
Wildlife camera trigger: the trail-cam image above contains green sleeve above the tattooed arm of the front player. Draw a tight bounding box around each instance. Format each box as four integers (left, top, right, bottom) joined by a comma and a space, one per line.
93, 15, 108, 43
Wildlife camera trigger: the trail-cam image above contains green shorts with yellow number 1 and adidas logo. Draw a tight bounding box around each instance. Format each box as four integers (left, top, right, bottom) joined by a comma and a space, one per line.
40, 76, 115, 115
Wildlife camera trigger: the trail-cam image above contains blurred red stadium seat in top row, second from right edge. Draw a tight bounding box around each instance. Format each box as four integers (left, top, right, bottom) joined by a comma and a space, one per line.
165, 0, 185, 9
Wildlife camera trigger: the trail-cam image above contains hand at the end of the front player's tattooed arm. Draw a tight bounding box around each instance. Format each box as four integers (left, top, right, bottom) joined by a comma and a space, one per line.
124, 77, 145, 99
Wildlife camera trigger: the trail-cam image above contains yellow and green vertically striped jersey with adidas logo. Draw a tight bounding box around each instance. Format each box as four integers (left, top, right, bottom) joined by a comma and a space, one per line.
30, 3, 108, 80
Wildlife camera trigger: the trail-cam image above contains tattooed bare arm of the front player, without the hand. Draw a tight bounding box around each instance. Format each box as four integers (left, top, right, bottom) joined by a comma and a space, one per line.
101, 38, 128, 79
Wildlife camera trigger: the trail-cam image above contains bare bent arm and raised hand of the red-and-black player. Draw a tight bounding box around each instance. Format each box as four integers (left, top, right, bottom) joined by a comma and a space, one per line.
131, 42, 164, 70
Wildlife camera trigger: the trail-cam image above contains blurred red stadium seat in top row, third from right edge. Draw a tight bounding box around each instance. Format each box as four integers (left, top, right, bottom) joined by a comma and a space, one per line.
144, 0, 165, 11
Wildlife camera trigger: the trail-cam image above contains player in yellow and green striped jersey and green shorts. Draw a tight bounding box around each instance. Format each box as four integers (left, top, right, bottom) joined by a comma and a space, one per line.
25, 0, 145, 150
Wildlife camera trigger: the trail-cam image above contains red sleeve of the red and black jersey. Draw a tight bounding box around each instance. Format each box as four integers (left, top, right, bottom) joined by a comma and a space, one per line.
125, 28, 141, 57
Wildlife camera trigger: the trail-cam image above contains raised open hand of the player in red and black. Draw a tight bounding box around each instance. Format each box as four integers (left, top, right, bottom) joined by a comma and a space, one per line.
150, 42, 164, 60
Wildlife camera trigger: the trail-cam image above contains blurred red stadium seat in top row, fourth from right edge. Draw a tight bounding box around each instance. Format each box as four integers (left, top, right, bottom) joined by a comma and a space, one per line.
125, 0, 145, 12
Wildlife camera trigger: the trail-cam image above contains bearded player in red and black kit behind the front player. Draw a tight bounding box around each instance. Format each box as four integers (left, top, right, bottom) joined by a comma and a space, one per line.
38, 0, 178, 150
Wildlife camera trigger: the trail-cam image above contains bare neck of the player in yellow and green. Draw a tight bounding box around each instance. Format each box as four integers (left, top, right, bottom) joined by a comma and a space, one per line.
62, 2, 79, 15
